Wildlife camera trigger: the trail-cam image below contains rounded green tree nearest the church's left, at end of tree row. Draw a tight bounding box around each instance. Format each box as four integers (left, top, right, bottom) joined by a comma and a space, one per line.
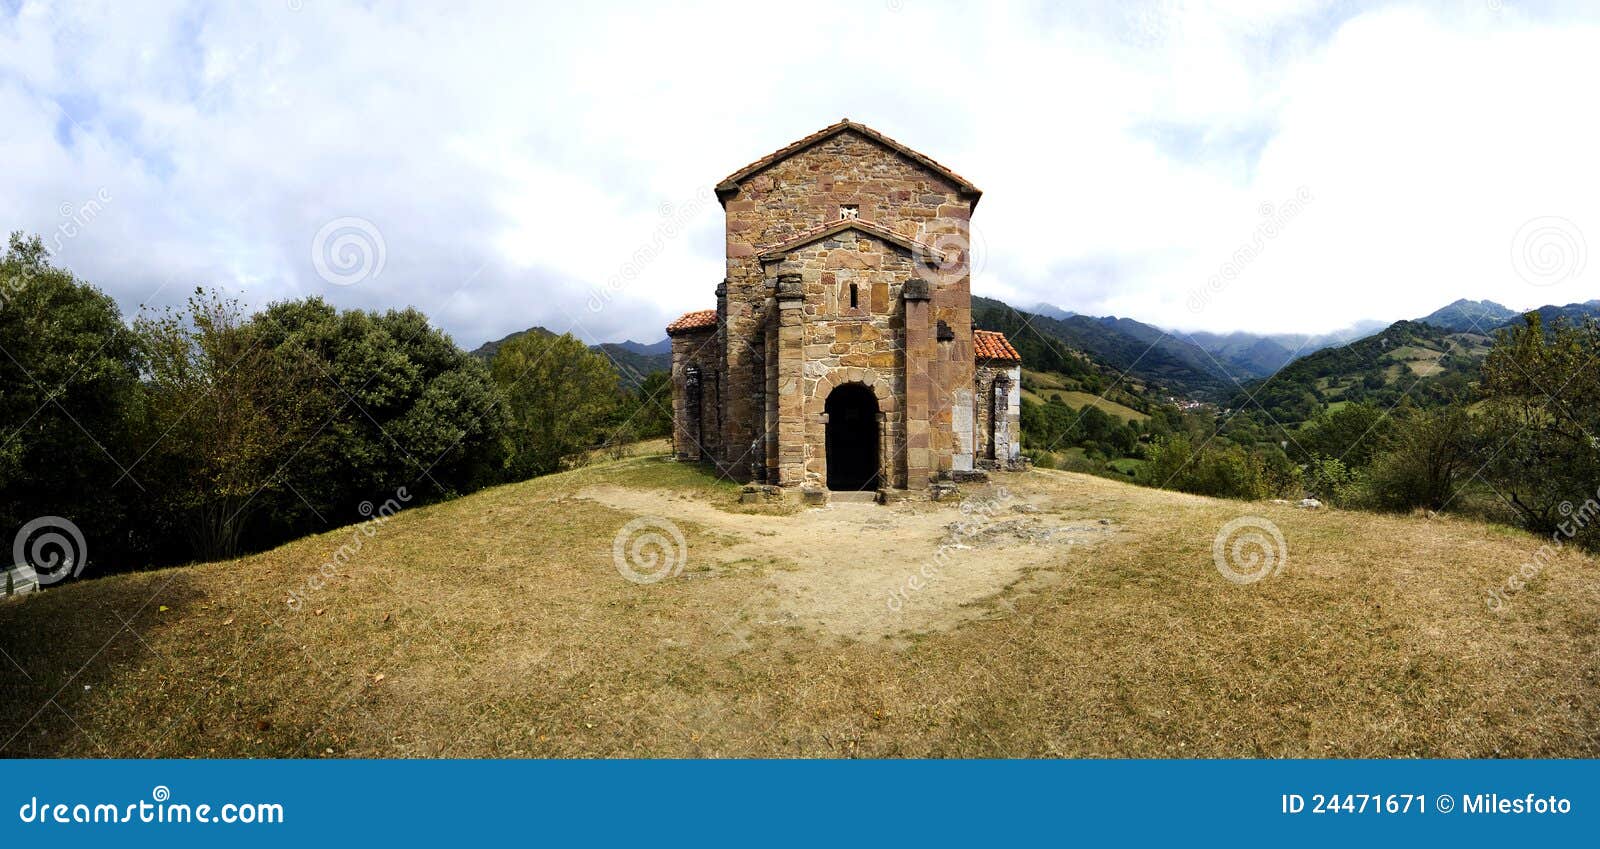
491, 333, 619, 476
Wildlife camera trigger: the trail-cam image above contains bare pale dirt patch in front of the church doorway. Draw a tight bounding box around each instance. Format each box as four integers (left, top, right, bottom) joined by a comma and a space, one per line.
578, 486, 1118, 640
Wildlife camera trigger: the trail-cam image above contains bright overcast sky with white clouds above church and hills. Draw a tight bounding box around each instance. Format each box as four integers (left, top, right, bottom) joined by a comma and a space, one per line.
0, 0, 1600, 347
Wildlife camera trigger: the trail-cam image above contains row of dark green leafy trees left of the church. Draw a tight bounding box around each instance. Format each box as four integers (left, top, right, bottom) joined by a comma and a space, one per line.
0, 233, 670, 572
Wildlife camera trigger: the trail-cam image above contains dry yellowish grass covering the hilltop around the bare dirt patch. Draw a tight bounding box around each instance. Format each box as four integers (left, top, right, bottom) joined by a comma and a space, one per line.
0, 457, 1600, 756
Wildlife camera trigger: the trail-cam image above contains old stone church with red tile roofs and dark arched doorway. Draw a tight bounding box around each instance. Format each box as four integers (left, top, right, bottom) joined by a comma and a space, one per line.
667, 120, 1022, 497
